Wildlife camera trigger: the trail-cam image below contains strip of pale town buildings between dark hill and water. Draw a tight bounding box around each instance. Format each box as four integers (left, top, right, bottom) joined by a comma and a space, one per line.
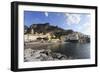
24, 24, 90, 43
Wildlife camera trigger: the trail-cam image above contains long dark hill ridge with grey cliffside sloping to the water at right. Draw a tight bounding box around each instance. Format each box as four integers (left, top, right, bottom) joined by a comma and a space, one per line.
24, 23, 90, 43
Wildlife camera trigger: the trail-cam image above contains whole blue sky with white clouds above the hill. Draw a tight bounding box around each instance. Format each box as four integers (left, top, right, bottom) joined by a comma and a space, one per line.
24, 11, 91, 35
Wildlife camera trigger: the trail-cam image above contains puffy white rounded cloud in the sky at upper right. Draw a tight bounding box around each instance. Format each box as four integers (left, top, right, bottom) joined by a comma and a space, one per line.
65, 13, 81, 25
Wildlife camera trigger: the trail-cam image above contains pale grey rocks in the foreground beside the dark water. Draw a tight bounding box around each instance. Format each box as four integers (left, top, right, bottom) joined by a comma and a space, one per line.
24, 48, 72, 62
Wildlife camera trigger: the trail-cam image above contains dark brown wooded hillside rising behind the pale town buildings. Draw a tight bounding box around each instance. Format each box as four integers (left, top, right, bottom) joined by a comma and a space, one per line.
24, 23, 73, 35
